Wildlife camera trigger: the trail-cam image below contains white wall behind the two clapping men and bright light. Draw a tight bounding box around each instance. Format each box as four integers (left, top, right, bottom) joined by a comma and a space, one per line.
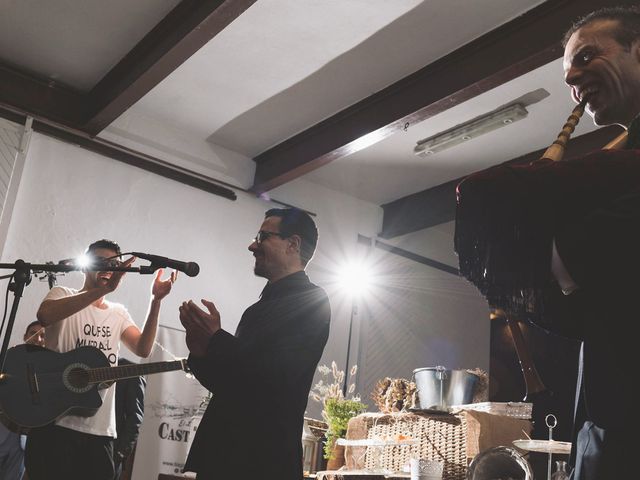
2, 130, 489, 417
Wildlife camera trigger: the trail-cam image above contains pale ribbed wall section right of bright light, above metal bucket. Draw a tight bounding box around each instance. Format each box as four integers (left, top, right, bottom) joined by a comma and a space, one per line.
357, 252, 490, 405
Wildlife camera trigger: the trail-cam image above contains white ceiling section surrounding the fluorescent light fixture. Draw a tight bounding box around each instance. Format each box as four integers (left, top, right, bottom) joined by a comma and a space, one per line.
305, 60, 596, 205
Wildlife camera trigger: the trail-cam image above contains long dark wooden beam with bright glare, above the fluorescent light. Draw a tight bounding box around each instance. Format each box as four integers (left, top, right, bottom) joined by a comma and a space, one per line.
251, 0, 635, 194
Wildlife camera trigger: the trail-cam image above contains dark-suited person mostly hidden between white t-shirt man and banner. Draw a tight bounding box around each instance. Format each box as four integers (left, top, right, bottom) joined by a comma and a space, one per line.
113, 357, 147, 480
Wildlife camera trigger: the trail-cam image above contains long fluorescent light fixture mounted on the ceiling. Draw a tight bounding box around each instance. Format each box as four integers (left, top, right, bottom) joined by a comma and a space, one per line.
413, 103, 529, 157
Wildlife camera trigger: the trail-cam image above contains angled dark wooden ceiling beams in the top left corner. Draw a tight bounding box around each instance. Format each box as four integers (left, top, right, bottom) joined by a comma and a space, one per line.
0, 0, 256, 136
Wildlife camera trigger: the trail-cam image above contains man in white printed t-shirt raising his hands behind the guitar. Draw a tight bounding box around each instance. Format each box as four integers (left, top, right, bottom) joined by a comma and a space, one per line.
25, 240, 176, 480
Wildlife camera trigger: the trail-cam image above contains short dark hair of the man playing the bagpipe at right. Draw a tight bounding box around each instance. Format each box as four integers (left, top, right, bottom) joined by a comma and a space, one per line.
562, 6, 640, 48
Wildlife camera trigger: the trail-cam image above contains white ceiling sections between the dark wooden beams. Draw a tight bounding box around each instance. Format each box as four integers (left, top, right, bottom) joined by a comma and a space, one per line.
0, 0, 593, 212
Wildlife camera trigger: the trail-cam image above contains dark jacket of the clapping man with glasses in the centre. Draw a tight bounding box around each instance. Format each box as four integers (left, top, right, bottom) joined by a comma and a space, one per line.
185, 272, 331, 480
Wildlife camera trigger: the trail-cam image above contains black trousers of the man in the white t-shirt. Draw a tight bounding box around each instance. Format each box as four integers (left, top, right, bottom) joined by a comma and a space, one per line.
25, 425, 114, 480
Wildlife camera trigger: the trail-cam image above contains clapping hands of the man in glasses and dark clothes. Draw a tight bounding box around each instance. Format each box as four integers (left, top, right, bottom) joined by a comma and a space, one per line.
179, 300, 221, 357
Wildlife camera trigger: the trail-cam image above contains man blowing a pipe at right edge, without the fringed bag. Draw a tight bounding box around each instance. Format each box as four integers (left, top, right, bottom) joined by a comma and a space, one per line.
542, 7, 640, 480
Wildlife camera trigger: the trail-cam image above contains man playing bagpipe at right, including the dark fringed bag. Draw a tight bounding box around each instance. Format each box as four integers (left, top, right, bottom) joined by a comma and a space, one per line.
456, 6, 640, 480
